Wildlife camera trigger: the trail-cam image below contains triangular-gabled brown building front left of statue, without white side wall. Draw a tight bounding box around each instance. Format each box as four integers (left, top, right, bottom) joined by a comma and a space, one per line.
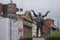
23, 11, 33, 37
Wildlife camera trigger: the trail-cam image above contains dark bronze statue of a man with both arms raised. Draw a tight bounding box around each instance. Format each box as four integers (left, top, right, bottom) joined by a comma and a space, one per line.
31, 10, 50, 37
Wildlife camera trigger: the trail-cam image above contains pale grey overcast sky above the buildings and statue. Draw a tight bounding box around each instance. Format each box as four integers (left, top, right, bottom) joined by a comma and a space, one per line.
0, 0, 60, 26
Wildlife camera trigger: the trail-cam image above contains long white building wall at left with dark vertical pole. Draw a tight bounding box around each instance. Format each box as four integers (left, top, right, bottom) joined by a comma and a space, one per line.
0, 17, 19, 40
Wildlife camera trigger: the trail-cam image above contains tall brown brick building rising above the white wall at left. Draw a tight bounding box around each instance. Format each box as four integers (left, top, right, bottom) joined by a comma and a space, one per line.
0, 3, 16, 17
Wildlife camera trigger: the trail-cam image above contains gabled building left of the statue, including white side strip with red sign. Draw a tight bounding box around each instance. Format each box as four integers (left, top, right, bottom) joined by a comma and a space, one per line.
19, 11, 33, 37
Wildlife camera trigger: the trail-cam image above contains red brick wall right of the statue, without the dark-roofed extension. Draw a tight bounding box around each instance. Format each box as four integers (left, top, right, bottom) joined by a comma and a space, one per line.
43, 19, 54, 35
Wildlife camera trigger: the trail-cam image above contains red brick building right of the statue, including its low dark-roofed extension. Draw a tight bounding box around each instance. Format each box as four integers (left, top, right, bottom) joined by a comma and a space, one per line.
43, 19, 57, 36
